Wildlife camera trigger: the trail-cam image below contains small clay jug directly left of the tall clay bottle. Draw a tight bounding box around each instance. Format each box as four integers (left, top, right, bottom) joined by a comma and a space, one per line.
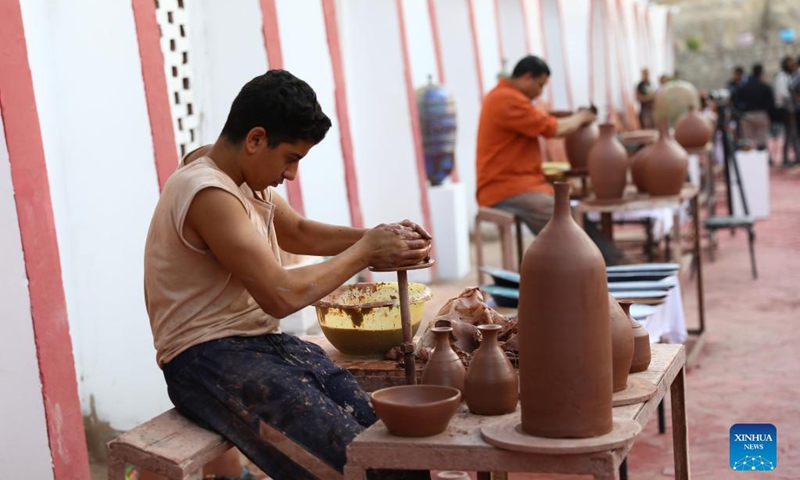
464, 324, 519, 415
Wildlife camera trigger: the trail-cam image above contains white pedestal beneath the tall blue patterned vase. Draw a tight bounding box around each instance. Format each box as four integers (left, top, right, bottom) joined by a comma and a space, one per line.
428, 183, 470, 280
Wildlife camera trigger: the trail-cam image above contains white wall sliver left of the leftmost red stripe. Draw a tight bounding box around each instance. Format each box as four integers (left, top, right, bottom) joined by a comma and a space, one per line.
0, 109, 53, 480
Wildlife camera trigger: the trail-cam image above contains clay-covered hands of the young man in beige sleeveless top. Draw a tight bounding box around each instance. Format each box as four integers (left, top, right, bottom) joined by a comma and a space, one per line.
362, 220, 431, 268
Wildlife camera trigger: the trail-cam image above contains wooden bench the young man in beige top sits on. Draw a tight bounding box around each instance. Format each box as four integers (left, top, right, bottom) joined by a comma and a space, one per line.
106, 409, 233, 480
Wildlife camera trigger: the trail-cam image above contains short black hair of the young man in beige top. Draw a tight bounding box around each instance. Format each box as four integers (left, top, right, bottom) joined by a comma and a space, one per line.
222, 70, 331, 148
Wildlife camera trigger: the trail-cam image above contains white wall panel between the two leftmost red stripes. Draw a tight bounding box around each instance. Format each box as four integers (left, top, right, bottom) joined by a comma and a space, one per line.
21, 0, 170, 429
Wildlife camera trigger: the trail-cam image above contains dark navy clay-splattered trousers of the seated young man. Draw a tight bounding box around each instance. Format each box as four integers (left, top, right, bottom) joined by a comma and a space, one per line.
164, 334, 430, 480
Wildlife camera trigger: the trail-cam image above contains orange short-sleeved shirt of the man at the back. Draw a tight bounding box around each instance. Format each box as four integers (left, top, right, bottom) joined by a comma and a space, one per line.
476, 79, 558, 206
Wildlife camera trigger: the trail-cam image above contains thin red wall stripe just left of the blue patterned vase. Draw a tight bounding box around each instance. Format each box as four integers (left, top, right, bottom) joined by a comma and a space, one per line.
394, 0, 436, 278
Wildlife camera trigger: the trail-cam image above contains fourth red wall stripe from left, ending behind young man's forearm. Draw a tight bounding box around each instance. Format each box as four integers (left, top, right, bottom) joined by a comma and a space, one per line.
322, 0, 364, 228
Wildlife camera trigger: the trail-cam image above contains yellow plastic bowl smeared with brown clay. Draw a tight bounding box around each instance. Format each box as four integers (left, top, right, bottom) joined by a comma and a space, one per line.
314, 282, 432, 357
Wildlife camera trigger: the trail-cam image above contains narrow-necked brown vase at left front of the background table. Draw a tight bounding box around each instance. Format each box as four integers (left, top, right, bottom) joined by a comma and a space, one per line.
587, 123, 628, 200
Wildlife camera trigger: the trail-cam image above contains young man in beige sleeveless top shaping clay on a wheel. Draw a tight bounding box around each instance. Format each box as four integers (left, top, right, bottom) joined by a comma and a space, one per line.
144, 70, 431, 480
